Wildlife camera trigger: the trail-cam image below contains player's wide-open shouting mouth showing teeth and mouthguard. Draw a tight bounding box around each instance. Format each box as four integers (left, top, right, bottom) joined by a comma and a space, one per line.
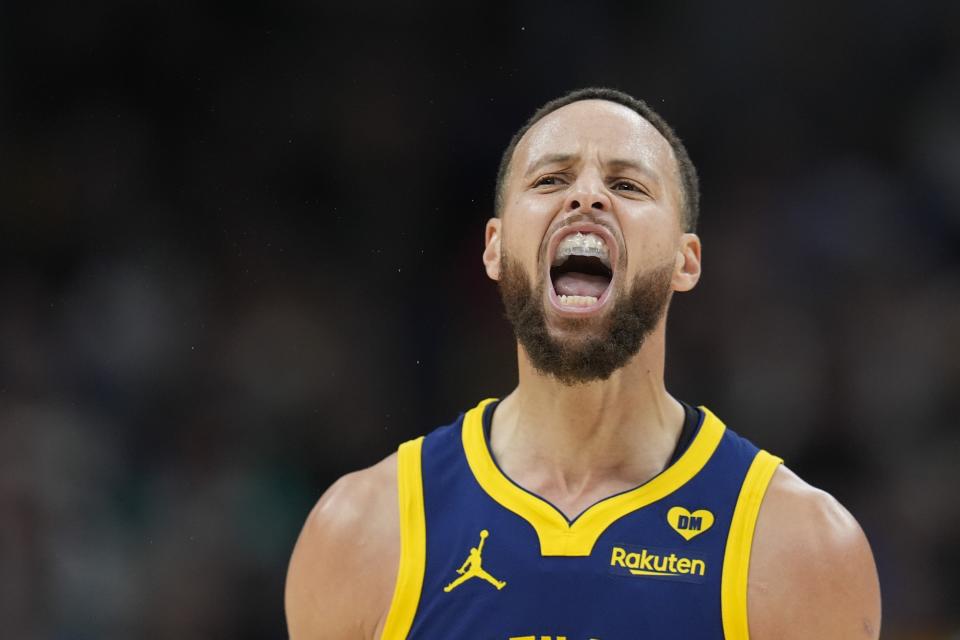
550, 231, 613, 308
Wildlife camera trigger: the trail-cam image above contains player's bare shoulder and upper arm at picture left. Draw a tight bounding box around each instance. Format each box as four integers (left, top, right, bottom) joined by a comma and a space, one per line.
284, 455, 400, 640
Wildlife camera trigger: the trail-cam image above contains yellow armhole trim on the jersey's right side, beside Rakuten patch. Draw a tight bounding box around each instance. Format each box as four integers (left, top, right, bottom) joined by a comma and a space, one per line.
720, 451, 783, 640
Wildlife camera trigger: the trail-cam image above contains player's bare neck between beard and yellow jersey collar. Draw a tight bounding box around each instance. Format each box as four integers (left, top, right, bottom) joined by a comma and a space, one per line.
490, 328, 684, 518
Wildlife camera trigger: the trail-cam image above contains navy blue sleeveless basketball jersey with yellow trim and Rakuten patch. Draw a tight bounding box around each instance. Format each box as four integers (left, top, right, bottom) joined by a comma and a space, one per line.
383, 400, 782, 640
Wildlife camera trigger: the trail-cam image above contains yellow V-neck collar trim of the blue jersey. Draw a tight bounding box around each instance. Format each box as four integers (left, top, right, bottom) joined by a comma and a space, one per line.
462, 398, 726, 556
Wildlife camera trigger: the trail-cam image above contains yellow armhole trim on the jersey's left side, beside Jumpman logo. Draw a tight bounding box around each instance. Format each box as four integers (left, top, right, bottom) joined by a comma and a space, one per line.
380, 437, 427, 640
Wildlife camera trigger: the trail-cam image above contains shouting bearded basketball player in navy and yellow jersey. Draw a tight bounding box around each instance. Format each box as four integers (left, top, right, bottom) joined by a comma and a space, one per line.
286, 89, 880, 640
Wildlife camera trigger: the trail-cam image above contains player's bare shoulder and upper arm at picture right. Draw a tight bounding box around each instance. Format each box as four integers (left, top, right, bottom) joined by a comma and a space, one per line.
747, 467, 880, 640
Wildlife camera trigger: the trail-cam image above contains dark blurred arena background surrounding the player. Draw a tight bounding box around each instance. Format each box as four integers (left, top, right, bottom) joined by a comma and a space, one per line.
0, 0, 960, 640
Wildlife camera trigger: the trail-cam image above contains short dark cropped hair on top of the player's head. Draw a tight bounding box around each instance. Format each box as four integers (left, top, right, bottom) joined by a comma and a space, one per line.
494, 87, 700, 232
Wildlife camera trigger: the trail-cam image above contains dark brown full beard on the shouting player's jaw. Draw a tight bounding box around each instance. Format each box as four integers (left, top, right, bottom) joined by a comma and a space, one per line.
498, 255, 673, 386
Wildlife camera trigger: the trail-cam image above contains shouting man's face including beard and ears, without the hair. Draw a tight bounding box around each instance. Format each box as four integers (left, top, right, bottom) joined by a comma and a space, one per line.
484, 100, 699, 383
